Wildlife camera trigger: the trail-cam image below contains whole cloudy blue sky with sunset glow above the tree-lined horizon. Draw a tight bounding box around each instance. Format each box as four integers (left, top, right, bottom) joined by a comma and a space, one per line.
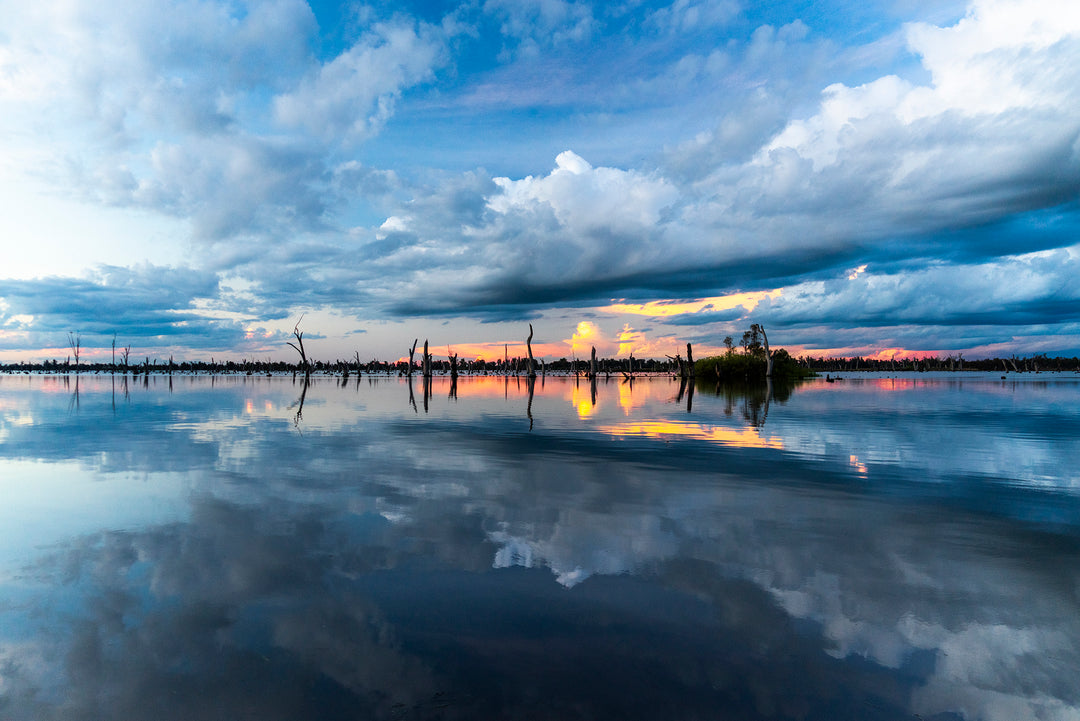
0, 0, 1080, 363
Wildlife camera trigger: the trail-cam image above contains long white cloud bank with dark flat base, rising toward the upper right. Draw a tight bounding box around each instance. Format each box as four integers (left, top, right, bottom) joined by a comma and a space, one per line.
360, 3, 1080, 332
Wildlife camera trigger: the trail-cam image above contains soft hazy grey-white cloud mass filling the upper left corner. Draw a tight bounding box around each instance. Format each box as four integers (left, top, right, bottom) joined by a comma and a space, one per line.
0, 0, 444, 241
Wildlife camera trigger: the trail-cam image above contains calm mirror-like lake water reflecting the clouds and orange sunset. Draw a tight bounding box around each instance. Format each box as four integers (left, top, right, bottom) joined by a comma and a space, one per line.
0, 373, 1080, 721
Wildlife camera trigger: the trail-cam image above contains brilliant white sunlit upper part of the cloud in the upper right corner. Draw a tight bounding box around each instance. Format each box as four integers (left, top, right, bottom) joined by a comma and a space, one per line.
757, 0, 1080, 171
